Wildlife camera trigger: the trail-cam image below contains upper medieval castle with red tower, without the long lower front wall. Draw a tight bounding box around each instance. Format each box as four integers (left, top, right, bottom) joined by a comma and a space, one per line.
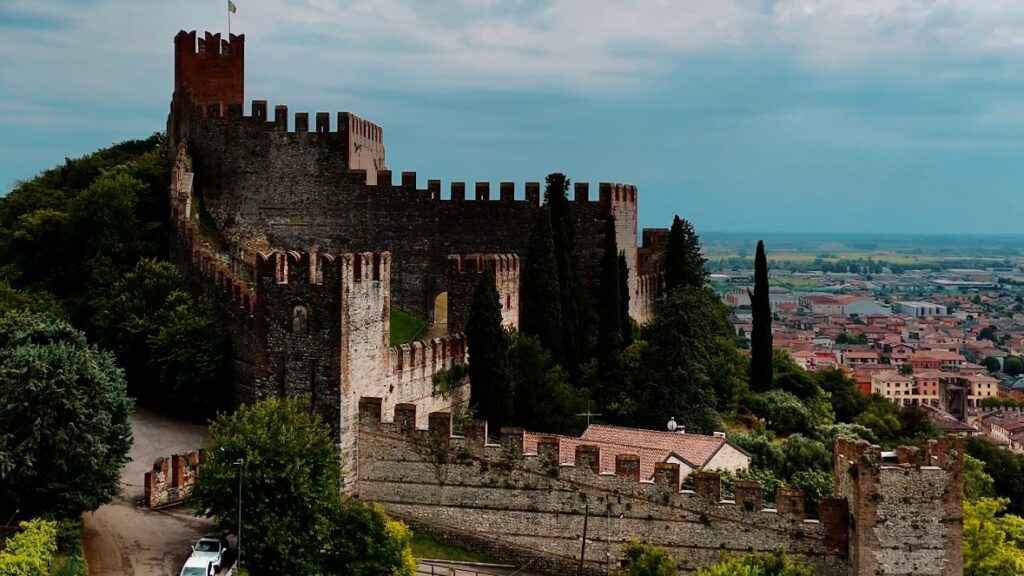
167, 31, 664, 467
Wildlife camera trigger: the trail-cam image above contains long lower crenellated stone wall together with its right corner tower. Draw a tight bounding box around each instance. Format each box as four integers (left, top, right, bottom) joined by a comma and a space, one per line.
355, 398, 963, 576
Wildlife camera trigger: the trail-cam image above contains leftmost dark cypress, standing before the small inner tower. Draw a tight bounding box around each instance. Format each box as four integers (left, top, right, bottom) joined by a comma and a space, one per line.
466, 268, 512, 433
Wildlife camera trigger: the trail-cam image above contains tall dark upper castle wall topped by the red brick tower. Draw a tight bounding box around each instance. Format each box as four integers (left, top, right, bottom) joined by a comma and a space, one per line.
168, 32, 651, 320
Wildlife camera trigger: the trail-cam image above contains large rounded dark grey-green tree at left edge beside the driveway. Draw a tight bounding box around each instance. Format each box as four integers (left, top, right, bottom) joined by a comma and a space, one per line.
0, 312, 132, 518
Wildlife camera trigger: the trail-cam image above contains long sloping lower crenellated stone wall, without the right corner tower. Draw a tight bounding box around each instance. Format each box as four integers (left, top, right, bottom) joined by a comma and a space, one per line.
356, 399, 849, 576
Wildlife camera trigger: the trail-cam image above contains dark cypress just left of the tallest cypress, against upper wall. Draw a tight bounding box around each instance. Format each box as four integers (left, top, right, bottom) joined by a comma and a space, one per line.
519, 207, 563, 363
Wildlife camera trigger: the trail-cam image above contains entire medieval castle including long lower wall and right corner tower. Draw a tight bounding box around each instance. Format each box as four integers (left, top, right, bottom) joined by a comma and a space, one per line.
169, 32, 963, 576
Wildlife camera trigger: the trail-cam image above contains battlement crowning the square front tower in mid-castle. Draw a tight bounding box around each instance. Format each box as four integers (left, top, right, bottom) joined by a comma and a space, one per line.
256, 251, 391, 284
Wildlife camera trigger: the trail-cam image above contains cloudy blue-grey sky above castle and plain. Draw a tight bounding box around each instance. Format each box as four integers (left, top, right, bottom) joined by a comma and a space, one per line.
0, 0, 1024, 234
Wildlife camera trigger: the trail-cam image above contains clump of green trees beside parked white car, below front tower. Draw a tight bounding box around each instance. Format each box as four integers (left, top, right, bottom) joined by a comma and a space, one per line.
189, 398, 415, 576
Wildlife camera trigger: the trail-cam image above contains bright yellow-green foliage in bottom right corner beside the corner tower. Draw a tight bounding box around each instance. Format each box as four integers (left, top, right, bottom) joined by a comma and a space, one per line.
964, 498, 1024, 576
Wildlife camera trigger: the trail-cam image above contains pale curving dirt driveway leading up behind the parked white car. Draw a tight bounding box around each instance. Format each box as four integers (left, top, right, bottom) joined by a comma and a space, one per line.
84, 408, 213, 576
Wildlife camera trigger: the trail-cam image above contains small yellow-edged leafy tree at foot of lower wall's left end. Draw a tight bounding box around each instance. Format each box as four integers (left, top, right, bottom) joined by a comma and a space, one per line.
324, 501, 416, 576
